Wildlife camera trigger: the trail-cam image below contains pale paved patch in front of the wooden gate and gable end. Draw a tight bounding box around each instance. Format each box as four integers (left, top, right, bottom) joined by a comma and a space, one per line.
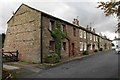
3, 62, 45, 78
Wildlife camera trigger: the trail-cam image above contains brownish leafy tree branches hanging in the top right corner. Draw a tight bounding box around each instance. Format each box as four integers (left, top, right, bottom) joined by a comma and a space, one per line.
97, 0, 120, 31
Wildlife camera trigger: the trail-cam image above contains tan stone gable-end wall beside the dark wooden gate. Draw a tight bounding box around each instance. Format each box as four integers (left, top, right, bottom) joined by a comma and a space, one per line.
4, 5, 41, 63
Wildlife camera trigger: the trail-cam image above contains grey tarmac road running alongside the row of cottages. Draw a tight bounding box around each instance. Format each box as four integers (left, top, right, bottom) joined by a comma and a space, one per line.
25, 50, 120, 78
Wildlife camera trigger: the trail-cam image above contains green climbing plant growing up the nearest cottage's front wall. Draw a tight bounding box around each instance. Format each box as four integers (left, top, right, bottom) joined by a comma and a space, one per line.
48, 21, 66, 57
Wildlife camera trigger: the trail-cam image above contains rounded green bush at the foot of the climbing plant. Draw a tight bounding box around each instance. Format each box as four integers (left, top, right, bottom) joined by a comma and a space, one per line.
46, 53, 60, 63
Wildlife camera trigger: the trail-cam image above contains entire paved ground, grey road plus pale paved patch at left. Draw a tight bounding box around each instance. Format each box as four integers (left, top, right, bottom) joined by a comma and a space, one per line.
3, 50, 118, 78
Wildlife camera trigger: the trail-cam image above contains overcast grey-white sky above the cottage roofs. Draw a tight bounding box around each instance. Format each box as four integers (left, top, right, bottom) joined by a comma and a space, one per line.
0, 0, 117, 39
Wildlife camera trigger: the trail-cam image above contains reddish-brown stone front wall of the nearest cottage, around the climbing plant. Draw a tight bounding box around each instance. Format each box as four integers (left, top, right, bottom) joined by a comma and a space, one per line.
42, 16, 80, 60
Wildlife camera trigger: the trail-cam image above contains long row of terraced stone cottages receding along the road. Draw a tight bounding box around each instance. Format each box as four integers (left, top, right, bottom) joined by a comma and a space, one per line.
4, 4, 111, 63
